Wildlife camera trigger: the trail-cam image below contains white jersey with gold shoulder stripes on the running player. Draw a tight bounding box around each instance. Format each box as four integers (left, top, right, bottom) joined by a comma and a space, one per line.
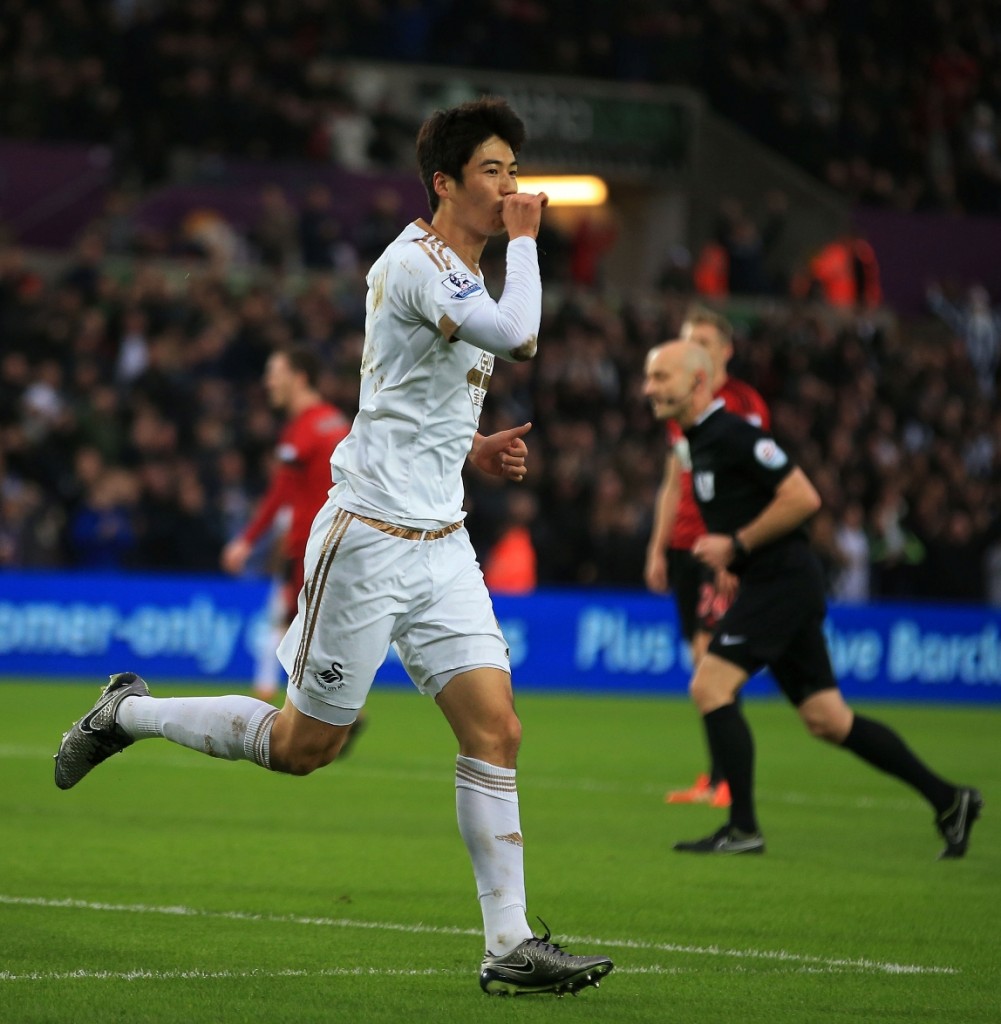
331, 220, 541, 529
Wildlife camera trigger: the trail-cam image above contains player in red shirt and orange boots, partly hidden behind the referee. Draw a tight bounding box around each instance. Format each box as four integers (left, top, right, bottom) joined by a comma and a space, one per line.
645, 306, 771, 807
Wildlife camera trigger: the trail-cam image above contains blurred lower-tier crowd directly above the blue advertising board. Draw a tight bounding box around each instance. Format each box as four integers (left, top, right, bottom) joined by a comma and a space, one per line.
0, 234, 1001, 603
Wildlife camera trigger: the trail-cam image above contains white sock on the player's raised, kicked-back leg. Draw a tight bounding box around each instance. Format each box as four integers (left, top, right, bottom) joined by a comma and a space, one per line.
116, 693, 278, 768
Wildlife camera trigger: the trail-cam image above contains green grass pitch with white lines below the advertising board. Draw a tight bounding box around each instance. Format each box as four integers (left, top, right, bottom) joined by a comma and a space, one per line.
0, 680, 1001, 1024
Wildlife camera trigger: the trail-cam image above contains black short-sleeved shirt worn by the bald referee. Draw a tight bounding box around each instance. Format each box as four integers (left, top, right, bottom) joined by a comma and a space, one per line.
685, 399, 809, 575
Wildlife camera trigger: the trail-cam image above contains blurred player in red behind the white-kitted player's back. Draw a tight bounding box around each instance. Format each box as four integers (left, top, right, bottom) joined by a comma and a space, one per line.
220, 345, 351, 699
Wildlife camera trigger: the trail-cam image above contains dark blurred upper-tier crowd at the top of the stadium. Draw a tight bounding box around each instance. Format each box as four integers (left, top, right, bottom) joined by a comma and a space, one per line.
0, 0, 1001, 214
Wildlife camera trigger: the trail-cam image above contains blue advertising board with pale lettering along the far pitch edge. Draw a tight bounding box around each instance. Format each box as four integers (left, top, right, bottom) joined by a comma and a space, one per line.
0, 572, 1001, 701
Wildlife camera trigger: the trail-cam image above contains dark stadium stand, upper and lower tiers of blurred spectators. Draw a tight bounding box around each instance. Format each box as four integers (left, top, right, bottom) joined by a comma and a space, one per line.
0, 0, 1001, 603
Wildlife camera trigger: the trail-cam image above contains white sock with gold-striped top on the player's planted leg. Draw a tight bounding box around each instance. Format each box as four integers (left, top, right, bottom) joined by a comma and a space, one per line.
455, 755, 532, 955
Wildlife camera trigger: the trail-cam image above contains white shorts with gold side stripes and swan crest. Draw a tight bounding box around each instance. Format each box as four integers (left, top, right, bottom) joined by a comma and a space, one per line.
278, 501, 511, 725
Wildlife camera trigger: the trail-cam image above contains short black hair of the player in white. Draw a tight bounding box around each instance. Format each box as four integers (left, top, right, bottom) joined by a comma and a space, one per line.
417, 96, 525, 214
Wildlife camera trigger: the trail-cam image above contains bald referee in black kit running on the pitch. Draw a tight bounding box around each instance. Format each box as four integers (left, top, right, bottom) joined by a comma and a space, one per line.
644, 341, 984, 857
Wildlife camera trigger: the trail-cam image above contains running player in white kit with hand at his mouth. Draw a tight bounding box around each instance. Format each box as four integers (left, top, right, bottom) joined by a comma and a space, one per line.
55, 97, 612, 994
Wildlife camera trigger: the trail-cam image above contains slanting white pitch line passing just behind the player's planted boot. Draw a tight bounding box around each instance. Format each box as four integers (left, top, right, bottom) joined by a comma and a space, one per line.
0, 894, 959, 981
